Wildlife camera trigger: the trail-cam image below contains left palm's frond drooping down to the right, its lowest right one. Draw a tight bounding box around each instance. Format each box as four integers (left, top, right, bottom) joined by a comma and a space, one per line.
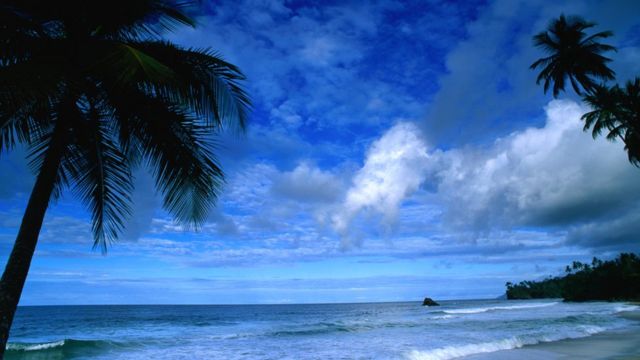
110, 93, 224, 228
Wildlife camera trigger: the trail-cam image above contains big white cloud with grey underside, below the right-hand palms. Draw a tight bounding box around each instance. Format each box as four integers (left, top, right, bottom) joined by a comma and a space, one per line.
436, 101, 640, 243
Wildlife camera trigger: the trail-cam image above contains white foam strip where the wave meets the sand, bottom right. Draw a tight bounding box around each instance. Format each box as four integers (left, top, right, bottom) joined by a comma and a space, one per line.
406, 326, 606, 360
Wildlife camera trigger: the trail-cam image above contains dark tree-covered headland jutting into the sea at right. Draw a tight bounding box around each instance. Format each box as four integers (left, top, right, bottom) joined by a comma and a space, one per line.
506, 253, 640, 301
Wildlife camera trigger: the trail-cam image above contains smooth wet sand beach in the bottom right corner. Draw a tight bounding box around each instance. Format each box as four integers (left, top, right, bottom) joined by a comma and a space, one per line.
460, 310, 640, 360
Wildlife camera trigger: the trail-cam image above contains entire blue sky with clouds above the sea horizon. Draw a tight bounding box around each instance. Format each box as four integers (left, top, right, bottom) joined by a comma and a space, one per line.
0, 0, 640, 305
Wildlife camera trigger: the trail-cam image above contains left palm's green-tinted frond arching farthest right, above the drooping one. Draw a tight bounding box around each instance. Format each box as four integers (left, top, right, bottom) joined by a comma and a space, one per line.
99, 41, 251, 130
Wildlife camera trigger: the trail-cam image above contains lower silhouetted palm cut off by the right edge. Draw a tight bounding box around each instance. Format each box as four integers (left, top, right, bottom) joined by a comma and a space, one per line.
582, 78, 640, 167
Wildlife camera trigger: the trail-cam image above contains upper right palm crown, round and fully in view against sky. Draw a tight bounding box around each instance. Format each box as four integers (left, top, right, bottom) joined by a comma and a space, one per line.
530, 15, 616, 97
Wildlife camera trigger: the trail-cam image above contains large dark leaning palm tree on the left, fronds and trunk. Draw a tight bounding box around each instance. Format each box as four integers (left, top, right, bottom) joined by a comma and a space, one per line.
0, 0, 250, 350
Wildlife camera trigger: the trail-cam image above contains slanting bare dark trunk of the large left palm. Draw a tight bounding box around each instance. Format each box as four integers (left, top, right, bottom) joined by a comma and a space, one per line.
0, 124, 66, 359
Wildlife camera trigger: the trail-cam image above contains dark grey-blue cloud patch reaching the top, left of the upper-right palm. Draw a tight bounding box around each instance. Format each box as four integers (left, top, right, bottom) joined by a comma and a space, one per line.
424, 1, 542, 146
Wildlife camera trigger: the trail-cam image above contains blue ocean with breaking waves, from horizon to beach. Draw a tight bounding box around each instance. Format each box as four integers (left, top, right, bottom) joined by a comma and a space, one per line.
5, 300, 639, 360
